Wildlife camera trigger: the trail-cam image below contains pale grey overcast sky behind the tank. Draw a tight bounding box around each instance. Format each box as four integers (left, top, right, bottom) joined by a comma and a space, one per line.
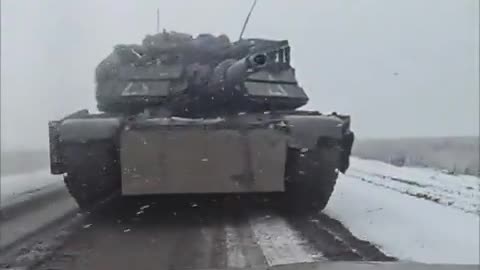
1, 0, 479, 148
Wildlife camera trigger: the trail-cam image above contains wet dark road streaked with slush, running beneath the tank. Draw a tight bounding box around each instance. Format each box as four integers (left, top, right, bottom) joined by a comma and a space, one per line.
0, 186, 478, 270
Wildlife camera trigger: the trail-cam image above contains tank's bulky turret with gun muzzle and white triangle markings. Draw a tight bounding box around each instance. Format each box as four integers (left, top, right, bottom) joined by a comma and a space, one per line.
96, 31, 308, 116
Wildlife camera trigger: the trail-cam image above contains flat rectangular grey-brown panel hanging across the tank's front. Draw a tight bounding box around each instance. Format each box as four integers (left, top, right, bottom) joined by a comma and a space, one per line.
120, 126, 287, 195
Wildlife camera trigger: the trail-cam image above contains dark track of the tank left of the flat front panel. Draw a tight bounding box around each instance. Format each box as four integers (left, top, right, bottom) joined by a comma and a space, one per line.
64, 142, 120, 211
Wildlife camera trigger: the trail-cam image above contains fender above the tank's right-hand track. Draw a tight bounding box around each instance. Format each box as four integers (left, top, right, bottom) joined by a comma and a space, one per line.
285, 115, 345, 149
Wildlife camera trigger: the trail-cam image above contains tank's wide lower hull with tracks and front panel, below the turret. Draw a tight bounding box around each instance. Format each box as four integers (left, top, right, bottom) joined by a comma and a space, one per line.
49, 111, 353, 209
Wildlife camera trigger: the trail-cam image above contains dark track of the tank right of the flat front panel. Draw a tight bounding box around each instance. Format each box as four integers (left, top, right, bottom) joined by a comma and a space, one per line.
282, 140, 342, 210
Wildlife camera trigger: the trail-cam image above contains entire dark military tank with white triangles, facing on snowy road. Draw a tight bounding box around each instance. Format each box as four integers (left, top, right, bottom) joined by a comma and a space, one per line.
49, 31, 354, 209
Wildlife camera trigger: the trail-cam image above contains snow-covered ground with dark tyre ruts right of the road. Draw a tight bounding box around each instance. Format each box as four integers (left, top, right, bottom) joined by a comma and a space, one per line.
325, 158, 480, 264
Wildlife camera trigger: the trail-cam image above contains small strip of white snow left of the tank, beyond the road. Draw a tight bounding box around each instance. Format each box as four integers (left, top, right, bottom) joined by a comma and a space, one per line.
0, 170, 63, 206
